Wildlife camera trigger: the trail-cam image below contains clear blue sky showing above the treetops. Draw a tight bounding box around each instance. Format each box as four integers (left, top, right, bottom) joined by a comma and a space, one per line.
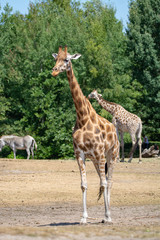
0, 0, 129, 29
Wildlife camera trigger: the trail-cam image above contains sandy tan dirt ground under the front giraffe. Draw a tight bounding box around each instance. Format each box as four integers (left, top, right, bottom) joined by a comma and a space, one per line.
0, 158, 160, 240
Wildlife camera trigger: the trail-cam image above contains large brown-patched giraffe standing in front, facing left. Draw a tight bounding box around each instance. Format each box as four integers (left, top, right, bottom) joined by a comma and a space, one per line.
52, 46, 119, 224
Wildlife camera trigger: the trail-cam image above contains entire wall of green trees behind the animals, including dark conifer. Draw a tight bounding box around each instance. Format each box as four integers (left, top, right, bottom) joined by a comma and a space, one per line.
0, 0, 160, 159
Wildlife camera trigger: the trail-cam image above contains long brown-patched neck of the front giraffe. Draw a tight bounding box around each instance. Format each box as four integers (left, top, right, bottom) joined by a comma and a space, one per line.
67, 63, 89, 127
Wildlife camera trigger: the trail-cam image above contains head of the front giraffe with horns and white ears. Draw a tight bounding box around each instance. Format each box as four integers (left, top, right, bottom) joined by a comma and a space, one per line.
52, 46, 81, 77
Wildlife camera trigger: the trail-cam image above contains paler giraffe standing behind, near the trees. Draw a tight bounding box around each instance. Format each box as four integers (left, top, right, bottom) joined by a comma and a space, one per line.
88, 90, 142, 163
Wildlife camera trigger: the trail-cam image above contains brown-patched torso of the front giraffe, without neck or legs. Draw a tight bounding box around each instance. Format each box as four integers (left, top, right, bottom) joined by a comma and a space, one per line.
73, 117, 116, 159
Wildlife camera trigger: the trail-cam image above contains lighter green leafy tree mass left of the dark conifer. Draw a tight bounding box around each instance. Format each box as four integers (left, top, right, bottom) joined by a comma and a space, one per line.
0, 0, 140, 158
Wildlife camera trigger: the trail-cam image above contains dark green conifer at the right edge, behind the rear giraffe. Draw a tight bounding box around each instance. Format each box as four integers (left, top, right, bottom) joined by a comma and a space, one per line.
127, 0, 160, 140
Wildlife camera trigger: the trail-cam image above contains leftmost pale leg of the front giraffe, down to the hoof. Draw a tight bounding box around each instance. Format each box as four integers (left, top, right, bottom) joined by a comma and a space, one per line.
76, 152, 88, 224
